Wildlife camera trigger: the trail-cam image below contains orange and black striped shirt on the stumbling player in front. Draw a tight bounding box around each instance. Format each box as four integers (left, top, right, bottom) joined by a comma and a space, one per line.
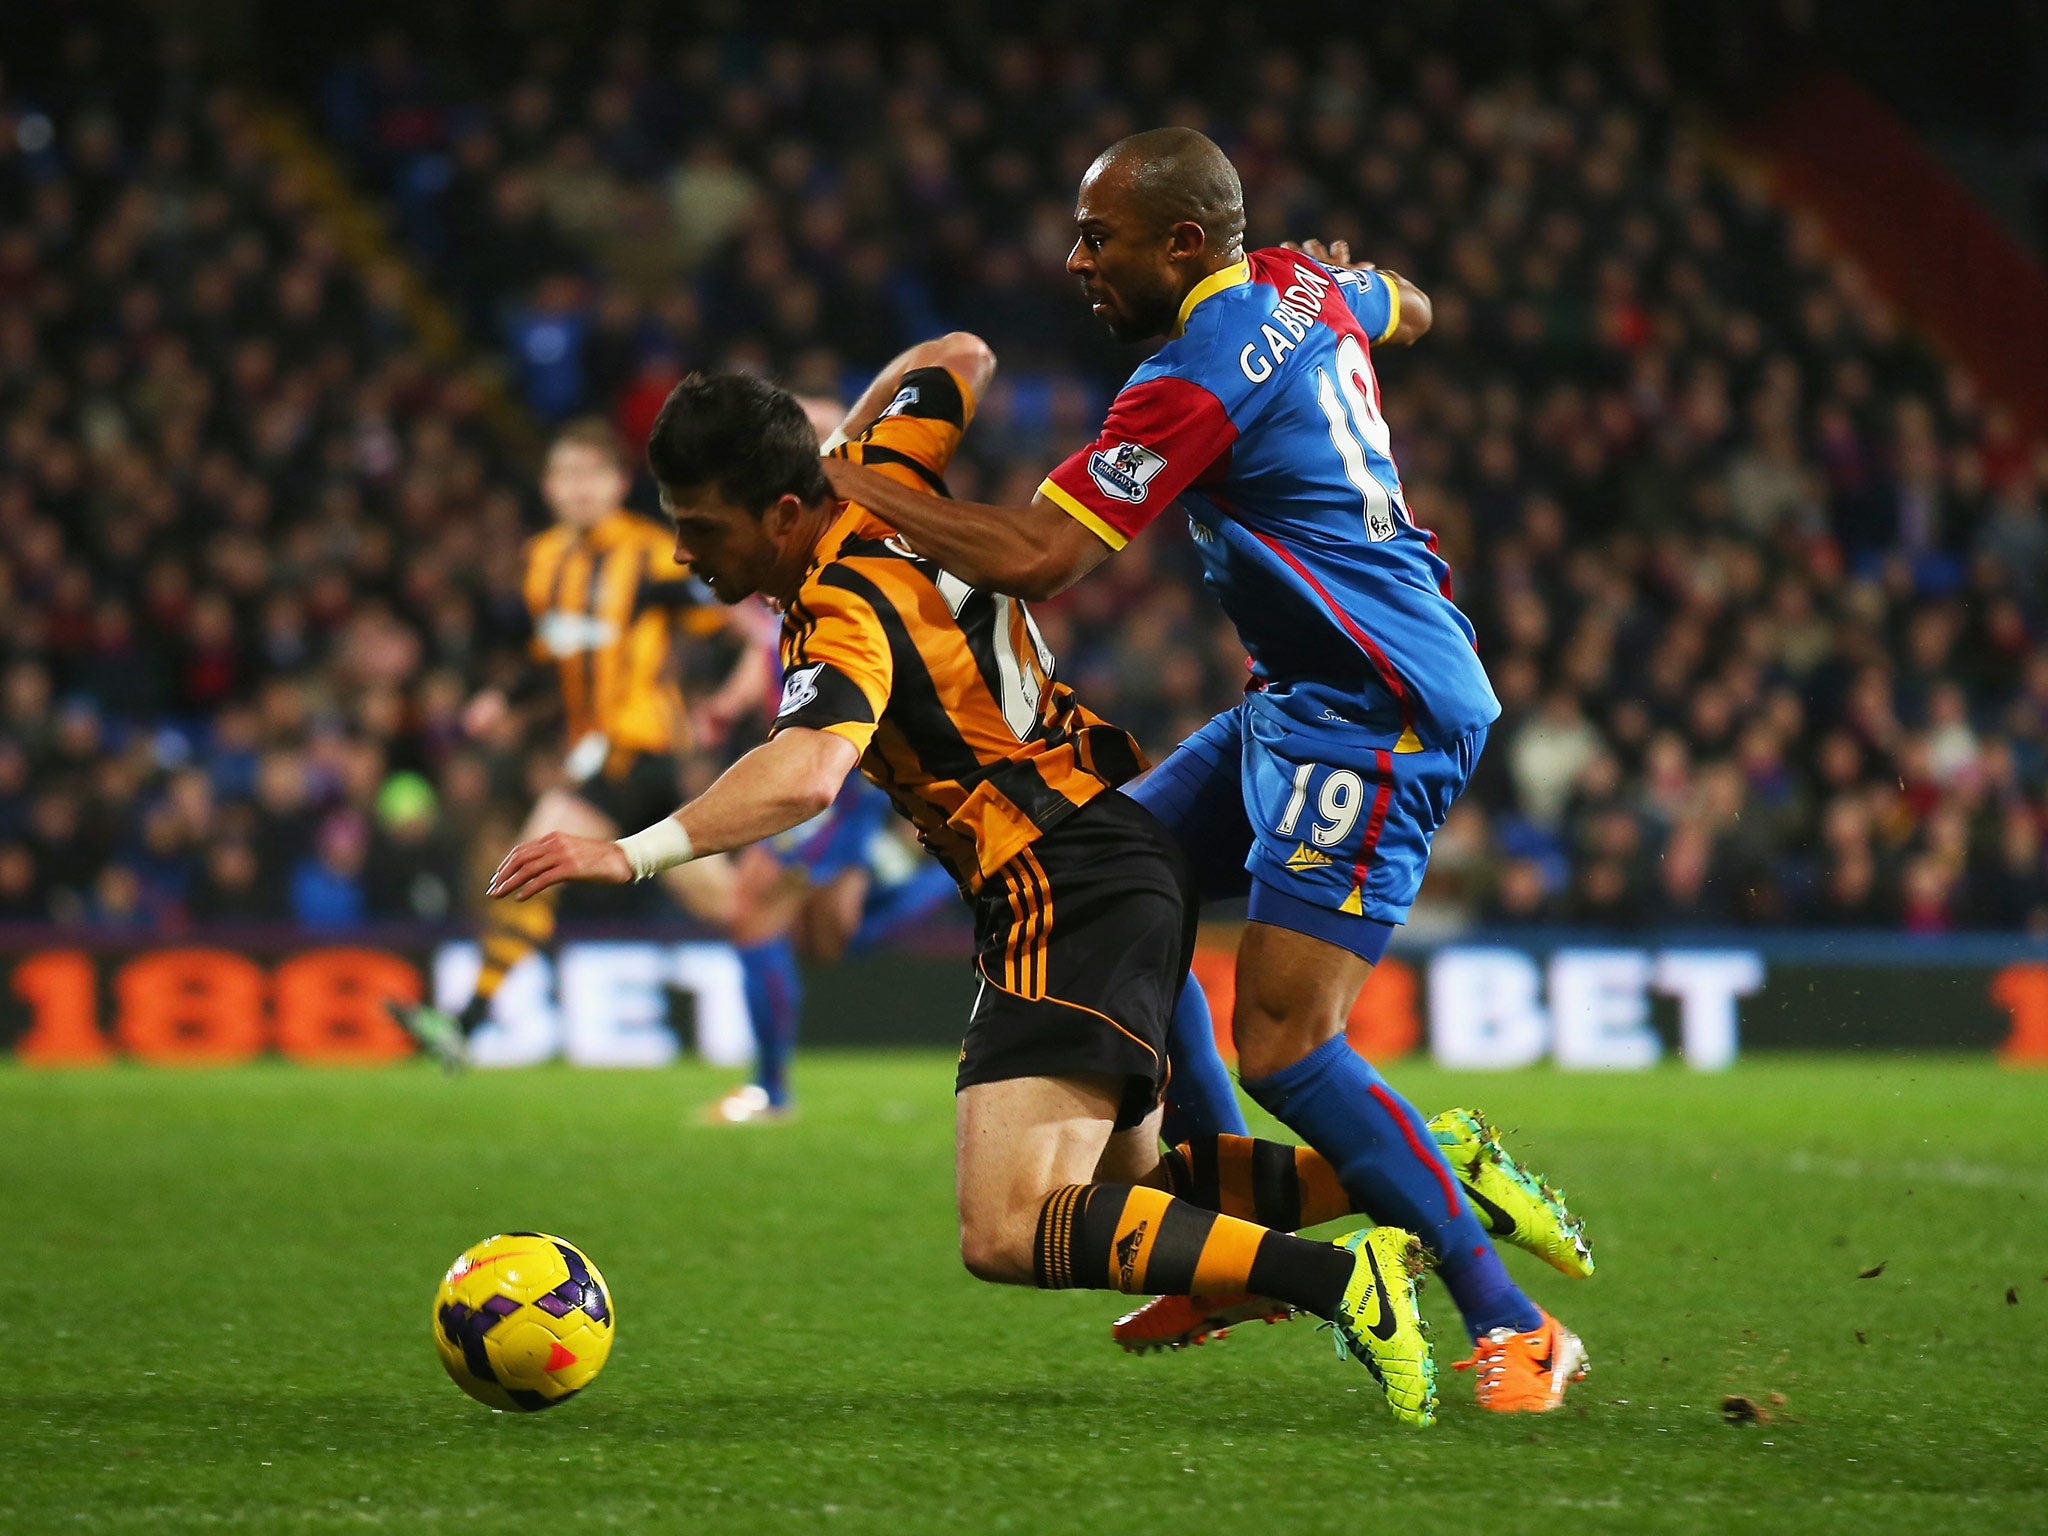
776, 367, 1145, 893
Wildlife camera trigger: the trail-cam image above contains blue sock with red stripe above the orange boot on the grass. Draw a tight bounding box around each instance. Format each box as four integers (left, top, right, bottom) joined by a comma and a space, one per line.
1245, 1034, 1542, 1339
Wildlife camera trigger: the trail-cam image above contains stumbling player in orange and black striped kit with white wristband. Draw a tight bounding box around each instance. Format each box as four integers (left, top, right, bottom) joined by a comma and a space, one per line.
479, 334, 1436, 1423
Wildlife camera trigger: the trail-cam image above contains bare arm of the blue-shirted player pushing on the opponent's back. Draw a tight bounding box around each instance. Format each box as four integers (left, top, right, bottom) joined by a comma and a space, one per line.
825, 459, 1110, 602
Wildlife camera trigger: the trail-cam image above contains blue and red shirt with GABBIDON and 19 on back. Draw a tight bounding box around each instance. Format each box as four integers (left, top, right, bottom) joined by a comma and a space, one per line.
1040, 248, 1501, 748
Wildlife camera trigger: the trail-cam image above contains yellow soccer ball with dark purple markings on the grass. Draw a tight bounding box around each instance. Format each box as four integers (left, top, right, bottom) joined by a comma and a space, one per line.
434, 1233, 614, 1413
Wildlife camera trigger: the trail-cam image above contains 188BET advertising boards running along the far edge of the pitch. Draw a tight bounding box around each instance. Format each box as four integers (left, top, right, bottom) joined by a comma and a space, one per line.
0, 930, 2048, 1071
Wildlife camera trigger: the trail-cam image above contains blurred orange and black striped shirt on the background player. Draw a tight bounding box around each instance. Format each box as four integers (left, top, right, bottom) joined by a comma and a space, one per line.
522, 510, 723, 752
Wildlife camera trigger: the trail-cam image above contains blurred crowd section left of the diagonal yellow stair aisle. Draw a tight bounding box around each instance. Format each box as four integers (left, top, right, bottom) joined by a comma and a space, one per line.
0, 33, 530, 928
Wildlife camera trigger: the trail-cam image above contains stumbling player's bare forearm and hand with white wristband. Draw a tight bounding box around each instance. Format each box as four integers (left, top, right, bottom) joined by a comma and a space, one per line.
487, 727, 860, 901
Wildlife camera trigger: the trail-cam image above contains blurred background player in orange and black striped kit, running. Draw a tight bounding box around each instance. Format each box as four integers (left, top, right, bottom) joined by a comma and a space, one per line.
391, 420, 753, 1065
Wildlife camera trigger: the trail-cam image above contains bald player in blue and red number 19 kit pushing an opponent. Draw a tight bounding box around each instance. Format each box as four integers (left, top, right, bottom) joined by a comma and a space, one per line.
827, 129, 1591, 1411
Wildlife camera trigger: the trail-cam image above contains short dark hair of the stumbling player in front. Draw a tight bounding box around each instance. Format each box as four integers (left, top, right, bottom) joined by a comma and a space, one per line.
647, 373, 831, 516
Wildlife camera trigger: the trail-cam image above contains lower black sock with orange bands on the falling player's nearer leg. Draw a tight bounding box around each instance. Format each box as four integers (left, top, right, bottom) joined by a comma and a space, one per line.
1032, 1184, 1354, 1317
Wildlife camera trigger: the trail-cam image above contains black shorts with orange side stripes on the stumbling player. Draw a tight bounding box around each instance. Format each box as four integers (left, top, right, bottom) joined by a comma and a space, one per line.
958, 791, 1194, 1130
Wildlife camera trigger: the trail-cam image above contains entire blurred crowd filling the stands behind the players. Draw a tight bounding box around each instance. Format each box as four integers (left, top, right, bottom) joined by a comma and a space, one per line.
0, 8, 2048, 932
